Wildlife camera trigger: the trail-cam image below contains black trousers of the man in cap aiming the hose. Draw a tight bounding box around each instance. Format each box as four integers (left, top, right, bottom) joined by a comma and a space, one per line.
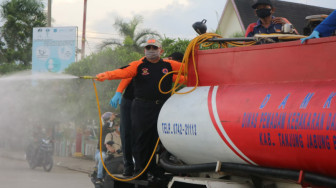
131, 98, 163, 172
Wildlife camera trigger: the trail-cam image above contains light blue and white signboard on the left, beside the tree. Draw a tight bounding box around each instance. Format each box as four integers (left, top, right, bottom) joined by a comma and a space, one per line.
32, 27, 77, 73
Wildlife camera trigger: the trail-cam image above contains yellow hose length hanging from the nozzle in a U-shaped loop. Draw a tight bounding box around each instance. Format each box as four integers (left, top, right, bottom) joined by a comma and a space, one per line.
79, 76, 160, 182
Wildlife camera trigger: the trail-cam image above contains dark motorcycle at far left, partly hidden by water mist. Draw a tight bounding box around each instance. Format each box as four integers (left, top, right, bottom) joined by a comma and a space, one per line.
26, 139, 53, 172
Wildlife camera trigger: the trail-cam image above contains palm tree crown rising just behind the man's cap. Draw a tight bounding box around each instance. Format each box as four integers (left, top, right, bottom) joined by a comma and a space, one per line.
99, 16, 161, 53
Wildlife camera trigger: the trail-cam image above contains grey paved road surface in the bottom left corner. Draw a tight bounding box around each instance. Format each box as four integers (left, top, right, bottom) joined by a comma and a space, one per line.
0, 157, 93, 188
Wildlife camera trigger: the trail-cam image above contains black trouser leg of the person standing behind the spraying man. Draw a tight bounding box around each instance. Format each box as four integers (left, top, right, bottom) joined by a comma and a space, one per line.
120, 97, 134, 171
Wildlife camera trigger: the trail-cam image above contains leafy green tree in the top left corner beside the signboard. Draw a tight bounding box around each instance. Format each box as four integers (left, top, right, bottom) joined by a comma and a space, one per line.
0, 0, 47, 69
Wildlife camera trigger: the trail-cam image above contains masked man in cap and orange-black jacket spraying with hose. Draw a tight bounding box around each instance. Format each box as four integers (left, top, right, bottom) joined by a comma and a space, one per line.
96, 39, 182, 178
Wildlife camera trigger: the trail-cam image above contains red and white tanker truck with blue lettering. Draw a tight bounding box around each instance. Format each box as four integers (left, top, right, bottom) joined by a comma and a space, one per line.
103, 34, 336, 188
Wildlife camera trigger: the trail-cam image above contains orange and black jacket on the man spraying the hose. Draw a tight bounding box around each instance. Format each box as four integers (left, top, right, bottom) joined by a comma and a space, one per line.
103, 58, 182, 101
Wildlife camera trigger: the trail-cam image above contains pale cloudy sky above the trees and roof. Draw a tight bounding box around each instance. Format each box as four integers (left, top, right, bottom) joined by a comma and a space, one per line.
0, 0, 336, 53
